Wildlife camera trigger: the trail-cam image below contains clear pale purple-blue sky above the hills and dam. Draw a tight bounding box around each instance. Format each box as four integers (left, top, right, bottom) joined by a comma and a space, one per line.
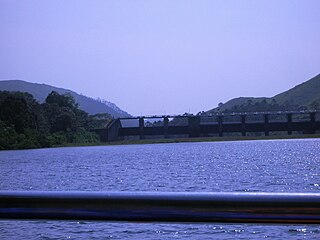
0, 0, 320, 115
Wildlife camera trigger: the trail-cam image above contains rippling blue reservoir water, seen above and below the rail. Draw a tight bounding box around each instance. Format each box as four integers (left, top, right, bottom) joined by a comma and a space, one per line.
0, 139, 320, 239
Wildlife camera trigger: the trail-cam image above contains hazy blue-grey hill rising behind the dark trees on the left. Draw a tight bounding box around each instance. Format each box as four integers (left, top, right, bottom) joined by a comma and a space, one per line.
0, 80, 130, 117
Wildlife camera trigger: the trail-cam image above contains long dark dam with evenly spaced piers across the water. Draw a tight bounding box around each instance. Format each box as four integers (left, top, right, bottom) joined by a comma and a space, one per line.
95, 111, 320, 142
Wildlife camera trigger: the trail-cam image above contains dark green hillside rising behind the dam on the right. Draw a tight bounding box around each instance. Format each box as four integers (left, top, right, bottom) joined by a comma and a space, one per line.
205, 74, 320, 114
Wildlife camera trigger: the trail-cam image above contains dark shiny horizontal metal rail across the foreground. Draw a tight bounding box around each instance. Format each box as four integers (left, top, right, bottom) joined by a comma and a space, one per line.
0, 191, 320, 224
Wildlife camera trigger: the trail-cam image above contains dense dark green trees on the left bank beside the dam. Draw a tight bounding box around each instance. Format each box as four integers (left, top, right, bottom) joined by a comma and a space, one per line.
0, 91, 112, 150
